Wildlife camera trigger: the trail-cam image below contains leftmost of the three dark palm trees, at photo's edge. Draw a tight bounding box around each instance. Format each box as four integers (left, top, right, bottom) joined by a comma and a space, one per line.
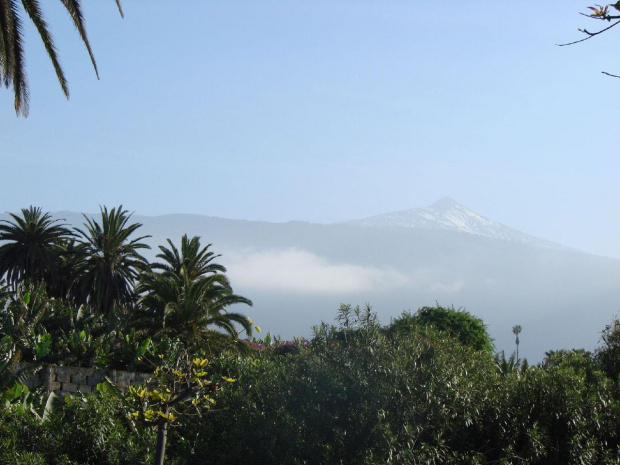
0, 206, 73, 288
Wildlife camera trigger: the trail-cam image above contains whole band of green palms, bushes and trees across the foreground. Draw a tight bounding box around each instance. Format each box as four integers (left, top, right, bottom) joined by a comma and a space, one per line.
0, 207, 620, 465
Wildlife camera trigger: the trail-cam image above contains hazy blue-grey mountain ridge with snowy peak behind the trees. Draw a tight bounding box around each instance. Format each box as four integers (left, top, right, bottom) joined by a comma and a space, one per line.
0, 199, 620, 362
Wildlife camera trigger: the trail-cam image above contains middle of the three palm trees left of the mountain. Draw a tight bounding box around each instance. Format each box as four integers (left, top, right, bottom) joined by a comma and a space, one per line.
72, 205, 150, 319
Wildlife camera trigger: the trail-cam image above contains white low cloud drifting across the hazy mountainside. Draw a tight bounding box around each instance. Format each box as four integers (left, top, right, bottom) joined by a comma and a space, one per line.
225, 249, 409, 294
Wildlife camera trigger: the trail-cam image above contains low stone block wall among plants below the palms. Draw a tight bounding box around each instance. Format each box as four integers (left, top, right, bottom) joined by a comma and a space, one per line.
20, 365, 151, 394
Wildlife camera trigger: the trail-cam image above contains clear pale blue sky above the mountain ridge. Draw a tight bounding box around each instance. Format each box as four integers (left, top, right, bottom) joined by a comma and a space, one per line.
0, 0, 620, 258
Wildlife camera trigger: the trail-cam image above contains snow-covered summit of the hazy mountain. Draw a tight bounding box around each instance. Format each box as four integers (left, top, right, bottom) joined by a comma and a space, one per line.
347, 197, 567, 250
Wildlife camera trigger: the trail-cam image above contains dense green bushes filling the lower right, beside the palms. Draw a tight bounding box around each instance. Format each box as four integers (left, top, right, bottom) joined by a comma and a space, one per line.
183, 309, 620, 464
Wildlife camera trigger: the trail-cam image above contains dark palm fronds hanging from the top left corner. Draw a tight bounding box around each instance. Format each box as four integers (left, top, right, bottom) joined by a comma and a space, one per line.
0, 0, 123, 116
